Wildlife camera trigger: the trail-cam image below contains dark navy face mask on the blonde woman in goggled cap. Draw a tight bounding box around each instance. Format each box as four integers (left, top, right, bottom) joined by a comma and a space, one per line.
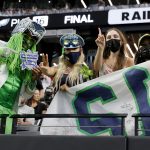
64, 52, 81, 64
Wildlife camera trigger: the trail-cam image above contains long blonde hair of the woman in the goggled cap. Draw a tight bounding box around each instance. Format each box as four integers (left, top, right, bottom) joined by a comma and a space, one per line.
54, 48, 84, 90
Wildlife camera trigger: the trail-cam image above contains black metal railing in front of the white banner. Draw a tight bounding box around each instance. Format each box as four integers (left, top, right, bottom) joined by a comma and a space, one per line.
0, 113, 150, 136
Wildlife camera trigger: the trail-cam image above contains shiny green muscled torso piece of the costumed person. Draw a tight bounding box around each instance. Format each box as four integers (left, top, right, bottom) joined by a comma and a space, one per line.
0, 69, 22, 109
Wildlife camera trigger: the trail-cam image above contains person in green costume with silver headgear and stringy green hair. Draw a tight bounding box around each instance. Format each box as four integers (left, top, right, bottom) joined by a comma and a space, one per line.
0, 18, 46, 133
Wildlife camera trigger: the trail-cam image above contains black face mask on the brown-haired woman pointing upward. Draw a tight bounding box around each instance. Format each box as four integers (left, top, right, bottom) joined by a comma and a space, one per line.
106, 39, 120, 53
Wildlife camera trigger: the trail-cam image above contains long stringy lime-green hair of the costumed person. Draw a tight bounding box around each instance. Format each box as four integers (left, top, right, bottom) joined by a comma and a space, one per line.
0, 33, 36, 82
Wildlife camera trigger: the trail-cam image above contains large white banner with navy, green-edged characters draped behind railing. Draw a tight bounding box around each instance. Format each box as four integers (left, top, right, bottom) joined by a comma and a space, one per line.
41, 61, 150, 135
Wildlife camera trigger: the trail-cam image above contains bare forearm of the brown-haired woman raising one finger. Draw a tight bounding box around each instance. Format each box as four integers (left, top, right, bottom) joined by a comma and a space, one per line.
94, 47, 103, 73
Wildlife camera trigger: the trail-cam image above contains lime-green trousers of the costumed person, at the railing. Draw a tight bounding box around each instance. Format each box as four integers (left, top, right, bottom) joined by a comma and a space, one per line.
0, 105, 15, 134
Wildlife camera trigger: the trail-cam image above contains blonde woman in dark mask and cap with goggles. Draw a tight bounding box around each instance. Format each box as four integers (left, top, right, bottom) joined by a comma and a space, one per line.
41, 34, 92, 93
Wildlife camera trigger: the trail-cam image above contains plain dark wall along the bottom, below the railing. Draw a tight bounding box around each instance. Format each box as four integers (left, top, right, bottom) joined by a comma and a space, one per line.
0, 135, 150, 150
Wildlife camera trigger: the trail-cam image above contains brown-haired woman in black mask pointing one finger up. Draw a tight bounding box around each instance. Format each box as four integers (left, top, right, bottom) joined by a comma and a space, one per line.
94, 28, 134, 76
